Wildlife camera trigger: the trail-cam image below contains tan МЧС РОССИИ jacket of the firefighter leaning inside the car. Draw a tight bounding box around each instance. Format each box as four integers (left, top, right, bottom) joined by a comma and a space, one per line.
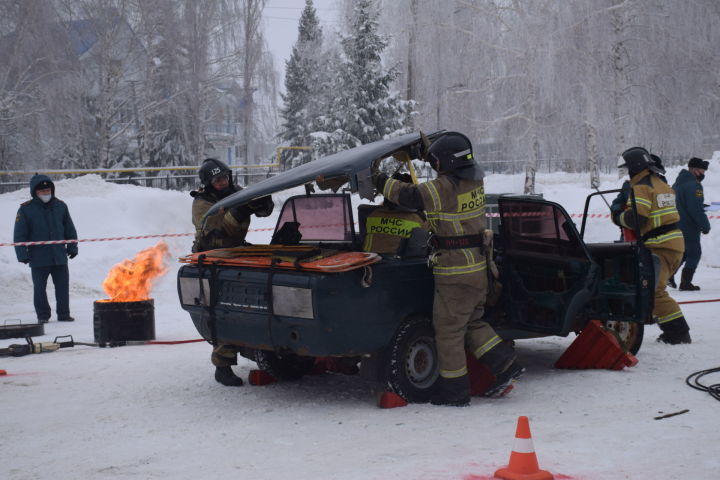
363, 205, 428, 255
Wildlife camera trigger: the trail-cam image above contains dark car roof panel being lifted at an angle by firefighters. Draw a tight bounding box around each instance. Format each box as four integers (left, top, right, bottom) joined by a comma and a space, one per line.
206, 132, 442, 216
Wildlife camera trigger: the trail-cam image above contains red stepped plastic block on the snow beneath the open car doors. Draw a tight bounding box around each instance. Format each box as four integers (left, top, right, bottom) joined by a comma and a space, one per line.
555, 320, 638, 370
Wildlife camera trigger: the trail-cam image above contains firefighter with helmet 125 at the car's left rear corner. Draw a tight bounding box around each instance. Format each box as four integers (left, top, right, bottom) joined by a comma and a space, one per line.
190, 158, 274, 387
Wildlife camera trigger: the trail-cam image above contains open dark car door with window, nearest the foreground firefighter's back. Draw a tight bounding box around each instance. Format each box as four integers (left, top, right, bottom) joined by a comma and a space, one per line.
498, 196, 598, 338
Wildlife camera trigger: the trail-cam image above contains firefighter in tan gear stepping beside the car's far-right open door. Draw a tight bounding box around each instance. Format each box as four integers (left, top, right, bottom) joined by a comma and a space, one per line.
612, 147, 691, 345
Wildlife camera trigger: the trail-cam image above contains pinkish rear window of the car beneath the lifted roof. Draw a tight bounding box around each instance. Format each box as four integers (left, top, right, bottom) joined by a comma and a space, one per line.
275, 195, 353, 242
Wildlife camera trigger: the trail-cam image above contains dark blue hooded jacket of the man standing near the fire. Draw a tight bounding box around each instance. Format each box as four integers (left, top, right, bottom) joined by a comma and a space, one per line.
13, 175, 78, 267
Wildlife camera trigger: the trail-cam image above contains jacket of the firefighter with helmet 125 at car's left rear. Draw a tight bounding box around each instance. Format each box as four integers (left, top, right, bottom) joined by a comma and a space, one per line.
190, 187, 250, 252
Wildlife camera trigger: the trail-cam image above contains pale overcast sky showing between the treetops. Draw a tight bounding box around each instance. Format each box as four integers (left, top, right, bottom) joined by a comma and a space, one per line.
263, 0, 341, 88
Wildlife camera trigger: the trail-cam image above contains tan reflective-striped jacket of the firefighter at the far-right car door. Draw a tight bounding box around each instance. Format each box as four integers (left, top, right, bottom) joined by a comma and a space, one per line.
617, 170, 685, 252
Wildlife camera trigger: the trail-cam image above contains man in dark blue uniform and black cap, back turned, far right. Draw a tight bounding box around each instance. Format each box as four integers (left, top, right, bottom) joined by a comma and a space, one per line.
671, 157, 710, 290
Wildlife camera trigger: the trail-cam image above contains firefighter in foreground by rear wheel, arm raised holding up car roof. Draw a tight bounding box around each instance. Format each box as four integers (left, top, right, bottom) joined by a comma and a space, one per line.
375, 132, 525, 406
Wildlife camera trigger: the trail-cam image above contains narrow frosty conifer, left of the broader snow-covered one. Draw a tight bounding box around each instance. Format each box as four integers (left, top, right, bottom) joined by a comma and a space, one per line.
280, 0, 322, 167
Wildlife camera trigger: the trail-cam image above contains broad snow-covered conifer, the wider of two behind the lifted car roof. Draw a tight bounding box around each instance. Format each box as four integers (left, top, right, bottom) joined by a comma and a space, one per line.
325, 0, 415, 151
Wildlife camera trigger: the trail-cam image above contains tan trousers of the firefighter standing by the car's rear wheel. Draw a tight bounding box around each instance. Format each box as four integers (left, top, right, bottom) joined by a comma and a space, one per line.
433, 271, 502, 378
